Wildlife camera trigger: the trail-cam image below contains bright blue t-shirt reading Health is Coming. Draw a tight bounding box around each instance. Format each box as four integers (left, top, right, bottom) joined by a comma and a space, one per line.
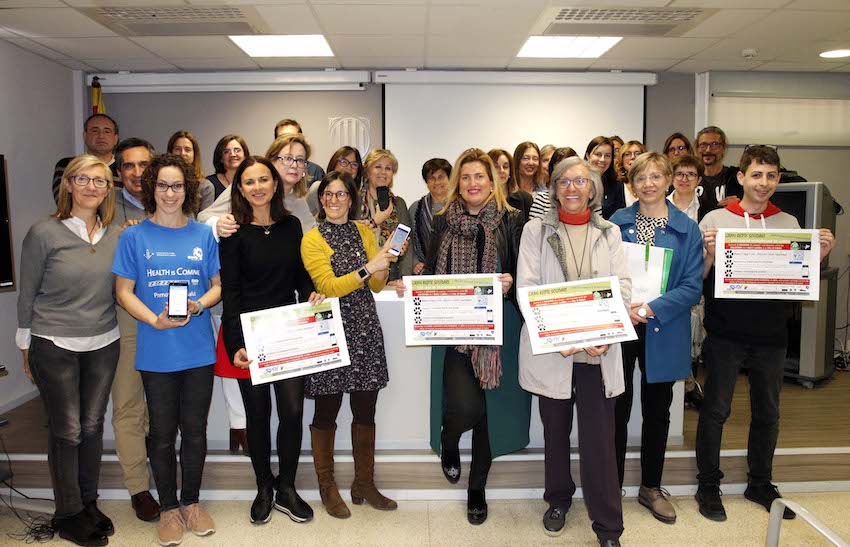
112, 220, 220, 372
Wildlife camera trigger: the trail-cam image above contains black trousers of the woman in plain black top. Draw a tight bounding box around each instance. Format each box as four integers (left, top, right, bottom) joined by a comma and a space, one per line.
239, 377, 304, 488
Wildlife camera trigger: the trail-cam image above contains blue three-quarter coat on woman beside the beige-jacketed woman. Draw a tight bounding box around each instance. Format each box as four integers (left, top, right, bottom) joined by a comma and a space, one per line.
610, 202, 703, 383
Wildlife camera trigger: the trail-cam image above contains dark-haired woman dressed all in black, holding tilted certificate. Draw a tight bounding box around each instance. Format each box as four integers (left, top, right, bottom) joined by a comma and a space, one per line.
216, 155, 323, 523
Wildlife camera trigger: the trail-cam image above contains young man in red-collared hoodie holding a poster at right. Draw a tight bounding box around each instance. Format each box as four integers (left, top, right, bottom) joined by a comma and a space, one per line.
696, 146, 835, 521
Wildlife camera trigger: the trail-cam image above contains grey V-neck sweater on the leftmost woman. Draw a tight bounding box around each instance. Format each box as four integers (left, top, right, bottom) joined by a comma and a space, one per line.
18, 217, 121, 337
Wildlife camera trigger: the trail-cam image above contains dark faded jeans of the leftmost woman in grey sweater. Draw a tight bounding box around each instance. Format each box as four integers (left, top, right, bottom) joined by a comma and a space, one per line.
29, 336, 119, 518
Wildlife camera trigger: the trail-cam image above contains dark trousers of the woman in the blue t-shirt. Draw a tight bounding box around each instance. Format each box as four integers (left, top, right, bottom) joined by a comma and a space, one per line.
141, 365, 213, 512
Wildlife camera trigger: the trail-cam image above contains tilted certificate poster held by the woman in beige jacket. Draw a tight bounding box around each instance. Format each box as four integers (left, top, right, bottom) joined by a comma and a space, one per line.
517, 277, 637, 355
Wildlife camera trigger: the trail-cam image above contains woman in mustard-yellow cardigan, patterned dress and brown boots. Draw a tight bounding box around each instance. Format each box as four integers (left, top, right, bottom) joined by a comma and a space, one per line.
301, 170, 400, 518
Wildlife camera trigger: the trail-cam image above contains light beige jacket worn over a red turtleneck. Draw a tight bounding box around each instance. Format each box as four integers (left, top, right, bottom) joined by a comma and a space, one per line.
516, 207, 632, 399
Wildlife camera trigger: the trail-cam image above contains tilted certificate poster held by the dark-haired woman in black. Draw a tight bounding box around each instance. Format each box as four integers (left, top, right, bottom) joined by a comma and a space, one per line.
240, 298, 351, 385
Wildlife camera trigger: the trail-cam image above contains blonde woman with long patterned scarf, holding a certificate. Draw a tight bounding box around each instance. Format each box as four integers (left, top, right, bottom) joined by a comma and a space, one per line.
423, 148, 531, 524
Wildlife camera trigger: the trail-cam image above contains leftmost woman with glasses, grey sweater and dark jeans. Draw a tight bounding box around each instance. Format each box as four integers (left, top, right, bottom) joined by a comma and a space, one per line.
15, 155, 121, 545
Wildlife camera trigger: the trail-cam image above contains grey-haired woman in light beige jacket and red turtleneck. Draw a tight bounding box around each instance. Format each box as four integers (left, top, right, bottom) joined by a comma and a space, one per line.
517, 156, 631, 546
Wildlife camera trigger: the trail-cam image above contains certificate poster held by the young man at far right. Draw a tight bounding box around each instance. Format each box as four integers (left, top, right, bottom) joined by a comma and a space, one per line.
714, 229, 820, 300
